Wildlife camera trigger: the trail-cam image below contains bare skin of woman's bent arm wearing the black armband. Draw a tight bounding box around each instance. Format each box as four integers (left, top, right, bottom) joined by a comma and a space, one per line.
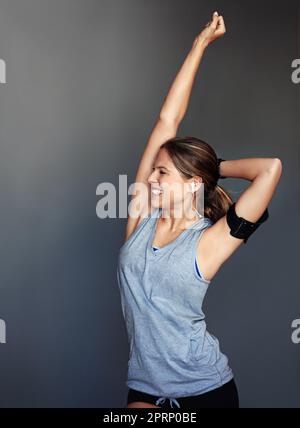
197, 158, 282, 281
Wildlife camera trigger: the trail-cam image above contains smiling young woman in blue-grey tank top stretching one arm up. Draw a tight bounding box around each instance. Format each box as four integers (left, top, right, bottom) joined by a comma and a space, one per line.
117, 12, 282, 408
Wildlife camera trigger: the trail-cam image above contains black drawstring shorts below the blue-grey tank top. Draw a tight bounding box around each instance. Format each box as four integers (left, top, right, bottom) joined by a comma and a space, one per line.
127, 378, 239, 409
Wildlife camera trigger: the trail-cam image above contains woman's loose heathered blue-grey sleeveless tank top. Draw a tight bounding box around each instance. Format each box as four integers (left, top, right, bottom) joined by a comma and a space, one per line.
117, 208, 233, 401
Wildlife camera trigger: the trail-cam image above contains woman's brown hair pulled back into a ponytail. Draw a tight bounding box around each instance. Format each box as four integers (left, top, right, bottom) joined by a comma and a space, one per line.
161, 137, 233, 222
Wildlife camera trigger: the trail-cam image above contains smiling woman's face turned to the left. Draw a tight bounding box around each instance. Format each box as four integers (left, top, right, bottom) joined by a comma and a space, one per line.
148, 149, 198, 210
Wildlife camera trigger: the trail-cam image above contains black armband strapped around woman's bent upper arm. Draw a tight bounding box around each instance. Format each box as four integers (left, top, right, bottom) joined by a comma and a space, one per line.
226, 202, 269, 244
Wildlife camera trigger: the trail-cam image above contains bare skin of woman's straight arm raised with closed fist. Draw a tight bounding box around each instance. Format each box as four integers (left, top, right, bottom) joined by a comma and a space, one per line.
125, 10, 226, 241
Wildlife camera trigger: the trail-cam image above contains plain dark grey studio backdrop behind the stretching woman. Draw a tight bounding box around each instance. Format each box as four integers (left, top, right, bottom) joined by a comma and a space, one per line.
0, 0, 300, 407
